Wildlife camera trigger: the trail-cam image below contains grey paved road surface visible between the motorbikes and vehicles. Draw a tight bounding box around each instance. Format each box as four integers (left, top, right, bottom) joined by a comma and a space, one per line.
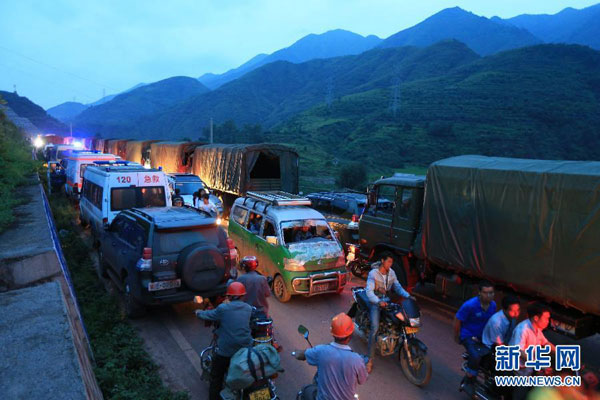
133, 281, 465, 400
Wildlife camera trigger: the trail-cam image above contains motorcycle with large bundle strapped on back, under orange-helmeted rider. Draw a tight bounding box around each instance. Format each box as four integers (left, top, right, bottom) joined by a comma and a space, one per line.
194, 300, 279, 400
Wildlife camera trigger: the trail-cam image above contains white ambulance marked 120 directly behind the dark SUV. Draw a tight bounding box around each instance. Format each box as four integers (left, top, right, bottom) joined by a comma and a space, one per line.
79, 161, 172, 244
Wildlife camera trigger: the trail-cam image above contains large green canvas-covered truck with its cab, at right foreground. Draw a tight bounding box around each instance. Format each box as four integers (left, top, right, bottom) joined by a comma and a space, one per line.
349, 156, 600, 338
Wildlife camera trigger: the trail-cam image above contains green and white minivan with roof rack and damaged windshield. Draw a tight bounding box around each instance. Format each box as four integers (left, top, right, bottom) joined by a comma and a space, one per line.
229, 191, 350, 302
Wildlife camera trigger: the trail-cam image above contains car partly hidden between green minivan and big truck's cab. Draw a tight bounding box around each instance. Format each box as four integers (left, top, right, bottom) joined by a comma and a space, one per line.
306, 191, 367, 252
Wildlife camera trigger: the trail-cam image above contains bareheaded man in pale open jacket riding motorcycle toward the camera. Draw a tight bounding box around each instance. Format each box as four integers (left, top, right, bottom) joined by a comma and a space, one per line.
366, 252, 416, 372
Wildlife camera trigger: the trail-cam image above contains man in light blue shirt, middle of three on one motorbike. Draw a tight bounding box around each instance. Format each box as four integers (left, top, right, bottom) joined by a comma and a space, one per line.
481, 294, 521, 349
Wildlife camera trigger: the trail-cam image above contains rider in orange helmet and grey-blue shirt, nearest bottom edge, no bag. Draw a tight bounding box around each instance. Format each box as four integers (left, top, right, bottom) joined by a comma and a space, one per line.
295, 313, 368, 400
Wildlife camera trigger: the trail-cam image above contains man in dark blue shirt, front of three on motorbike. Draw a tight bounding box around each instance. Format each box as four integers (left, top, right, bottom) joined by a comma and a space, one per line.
454, 281, 496, 389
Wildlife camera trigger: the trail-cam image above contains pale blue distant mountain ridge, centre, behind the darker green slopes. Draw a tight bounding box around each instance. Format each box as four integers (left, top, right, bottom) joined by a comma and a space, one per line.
198, 29, 381, 89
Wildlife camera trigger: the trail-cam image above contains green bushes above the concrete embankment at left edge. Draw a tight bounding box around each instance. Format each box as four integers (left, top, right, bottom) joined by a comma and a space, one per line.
0, 103, 36, 232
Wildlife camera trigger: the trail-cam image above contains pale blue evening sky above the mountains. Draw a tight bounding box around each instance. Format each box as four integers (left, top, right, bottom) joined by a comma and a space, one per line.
0, 0, 598, 108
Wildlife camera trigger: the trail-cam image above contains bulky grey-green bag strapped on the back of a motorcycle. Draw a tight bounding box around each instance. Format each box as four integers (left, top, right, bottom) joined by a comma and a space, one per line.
225, 344, 283, 390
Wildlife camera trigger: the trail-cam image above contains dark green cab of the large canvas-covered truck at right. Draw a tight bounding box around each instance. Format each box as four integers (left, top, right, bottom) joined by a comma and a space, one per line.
358, 174, 425, 287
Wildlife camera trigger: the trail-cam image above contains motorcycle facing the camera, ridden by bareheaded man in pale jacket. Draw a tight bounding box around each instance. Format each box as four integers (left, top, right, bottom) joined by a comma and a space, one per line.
348, 287, 431, 387
